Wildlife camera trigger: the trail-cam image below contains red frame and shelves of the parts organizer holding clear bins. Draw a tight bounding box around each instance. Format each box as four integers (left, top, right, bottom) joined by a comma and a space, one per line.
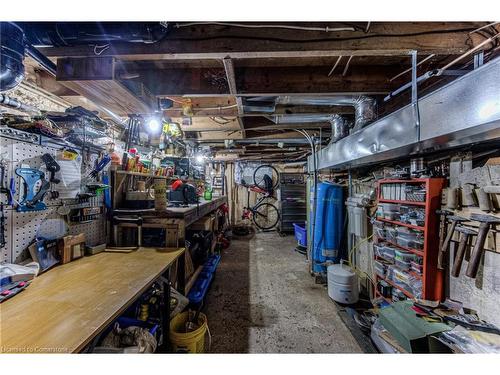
374, 178, 446, 302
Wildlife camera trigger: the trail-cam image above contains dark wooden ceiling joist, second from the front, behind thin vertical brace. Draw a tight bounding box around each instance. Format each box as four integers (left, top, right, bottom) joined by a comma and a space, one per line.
136, 66, 402, 96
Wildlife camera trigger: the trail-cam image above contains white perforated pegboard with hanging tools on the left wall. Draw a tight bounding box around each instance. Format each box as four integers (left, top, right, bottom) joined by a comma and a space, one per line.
0, 137, 106, 263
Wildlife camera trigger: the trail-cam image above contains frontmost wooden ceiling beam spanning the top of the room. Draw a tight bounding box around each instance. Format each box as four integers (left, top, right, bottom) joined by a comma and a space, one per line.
40, 22, 484, 60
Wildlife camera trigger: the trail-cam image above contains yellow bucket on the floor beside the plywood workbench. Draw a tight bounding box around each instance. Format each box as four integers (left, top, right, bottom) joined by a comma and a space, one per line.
170, 311, 211, 353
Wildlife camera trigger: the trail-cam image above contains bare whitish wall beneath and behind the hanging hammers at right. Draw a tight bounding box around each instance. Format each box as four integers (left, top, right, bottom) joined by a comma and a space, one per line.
449, 245, 500, 327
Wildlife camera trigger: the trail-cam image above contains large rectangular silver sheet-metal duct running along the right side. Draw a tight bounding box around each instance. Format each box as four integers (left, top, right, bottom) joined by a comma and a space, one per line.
308, 58, 500, 171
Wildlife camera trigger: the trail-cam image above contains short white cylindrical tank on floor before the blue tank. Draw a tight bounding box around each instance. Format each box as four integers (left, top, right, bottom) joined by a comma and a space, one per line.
327, 264, 359, 304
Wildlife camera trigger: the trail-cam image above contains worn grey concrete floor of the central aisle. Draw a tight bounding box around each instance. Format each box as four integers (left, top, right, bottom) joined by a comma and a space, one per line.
204, 232, 362, 353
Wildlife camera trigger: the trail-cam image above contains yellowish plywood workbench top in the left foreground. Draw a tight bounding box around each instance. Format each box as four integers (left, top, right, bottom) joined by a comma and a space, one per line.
0, 248, 184, 353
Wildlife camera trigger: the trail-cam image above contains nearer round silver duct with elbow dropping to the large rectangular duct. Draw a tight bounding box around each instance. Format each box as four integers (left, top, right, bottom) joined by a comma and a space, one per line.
276, 95, 377, 131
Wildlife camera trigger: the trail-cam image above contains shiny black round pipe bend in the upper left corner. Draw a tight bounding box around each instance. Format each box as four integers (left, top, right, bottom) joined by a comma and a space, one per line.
0, 22, 24, 92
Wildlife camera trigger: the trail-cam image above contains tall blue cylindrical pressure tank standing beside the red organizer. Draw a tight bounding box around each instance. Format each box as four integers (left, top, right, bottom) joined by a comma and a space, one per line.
312, 182, 344, 273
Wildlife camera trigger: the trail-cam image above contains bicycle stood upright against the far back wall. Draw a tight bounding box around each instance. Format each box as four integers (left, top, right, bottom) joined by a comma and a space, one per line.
242, 165, 280, 230
